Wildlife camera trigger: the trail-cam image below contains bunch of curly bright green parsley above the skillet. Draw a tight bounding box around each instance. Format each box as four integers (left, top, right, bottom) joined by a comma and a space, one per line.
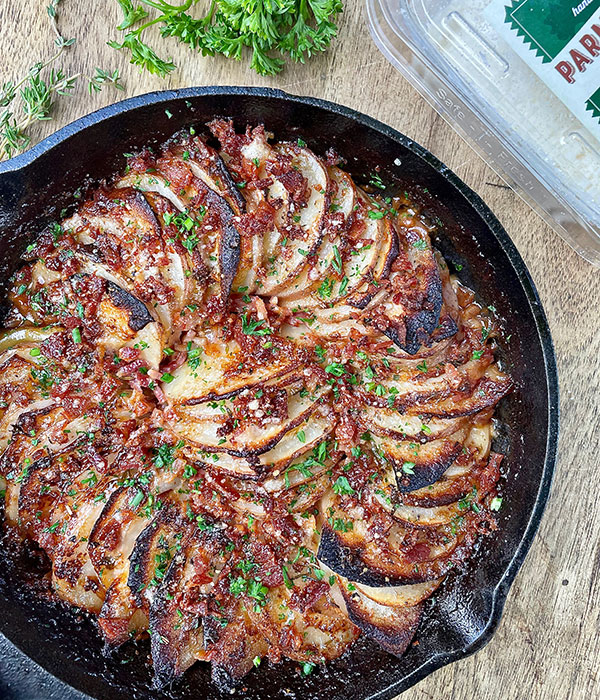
108, 0, 343, 77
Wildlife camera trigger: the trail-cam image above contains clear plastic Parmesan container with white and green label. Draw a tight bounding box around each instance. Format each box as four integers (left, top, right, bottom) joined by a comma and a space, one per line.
367, 0, 600, 267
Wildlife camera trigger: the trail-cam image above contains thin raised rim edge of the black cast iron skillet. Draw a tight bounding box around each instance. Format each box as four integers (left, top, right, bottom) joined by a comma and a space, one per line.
0, 86, 560, 700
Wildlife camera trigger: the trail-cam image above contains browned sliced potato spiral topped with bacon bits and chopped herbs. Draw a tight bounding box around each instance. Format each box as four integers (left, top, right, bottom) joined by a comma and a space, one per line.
0, 120, 511, 687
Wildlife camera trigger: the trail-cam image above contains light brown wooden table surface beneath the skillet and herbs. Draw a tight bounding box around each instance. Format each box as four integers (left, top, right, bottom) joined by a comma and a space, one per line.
0, 0, 600, 700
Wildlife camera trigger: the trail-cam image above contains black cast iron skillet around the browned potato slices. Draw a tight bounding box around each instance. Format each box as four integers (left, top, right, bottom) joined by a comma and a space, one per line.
0, 87, 558, 700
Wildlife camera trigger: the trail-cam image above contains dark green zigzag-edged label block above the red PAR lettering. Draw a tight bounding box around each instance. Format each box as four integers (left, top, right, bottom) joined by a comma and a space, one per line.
505, 0, 600, 63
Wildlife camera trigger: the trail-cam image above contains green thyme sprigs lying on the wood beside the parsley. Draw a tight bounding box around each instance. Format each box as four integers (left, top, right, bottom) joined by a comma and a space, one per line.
0, 0, 124, 160
